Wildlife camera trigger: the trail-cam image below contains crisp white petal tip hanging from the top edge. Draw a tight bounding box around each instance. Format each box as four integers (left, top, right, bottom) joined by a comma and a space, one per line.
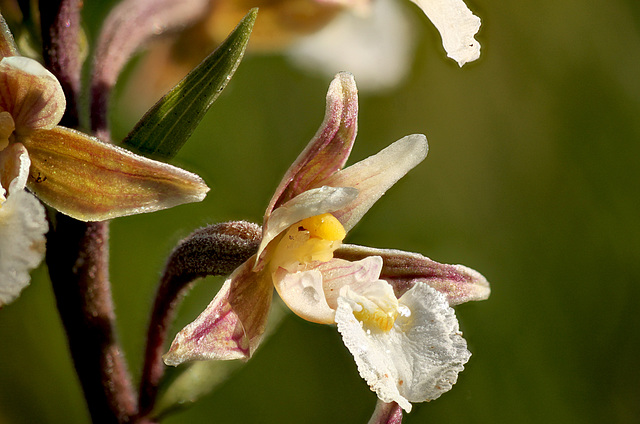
411, 0, 480, 66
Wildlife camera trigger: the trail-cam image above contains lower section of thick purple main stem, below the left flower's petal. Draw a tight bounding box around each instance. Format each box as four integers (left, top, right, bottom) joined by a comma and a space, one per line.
47, 214, 137, 423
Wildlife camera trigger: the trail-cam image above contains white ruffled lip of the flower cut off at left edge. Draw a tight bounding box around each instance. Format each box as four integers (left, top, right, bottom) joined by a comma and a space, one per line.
0, 147, 48, 307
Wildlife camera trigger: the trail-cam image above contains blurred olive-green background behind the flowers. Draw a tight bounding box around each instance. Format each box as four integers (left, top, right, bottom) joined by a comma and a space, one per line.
0, 0, 640, 424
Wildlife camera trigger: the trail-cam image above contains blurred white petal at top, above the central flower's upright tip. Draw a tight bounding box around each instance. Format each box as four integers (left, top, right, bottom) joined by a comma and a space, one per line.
287, 0, 415, 91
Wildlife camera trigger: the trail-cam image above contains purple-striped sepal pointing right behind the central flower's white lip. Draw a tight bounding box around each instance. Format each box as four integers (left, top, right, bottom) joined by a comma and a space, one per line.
334, 244, 491, 306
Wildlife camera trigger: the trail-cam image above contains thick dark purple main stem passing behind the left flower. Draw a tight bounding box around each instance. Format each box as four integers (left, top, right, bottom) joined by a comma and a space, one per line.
39, 0, 137, 423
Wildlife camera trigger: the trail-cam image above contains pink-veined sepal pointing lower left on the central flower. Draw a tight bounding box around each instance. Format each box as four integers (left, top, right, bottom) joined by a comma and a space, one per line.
164, 258, 273, 366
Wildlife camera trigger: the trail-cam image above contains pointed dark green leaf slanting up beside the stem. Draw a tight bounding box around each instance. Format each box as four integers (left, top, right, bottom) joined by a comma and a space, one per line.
123, 9, 258, 159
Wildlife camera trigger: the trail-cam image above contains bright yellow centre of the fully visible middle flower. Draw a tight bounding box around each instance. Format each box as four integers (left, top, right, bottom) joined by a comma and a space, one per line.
271, 213, 347, 272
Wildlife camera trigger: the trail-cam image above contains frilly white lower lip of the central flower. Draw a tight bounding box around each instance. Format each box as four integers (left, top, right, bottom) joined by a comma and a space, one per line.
336, 283, 471, 412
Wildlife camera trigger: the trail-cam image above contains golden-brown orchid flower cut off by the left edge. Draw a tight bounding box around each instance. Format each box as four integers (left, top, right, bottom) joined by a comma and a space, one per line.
0, 16, 209, 307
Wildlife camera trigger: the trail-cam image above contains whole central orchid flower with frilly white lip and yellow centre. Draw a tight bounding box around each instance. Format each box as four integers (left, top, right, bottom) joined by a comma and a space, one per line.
165, 73, 489, 411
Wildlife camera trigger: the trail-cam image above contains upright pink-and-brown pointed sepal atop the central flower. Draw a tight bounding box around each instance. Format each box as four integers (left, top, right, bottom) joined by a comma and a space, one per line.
264, 72, 358, 217
